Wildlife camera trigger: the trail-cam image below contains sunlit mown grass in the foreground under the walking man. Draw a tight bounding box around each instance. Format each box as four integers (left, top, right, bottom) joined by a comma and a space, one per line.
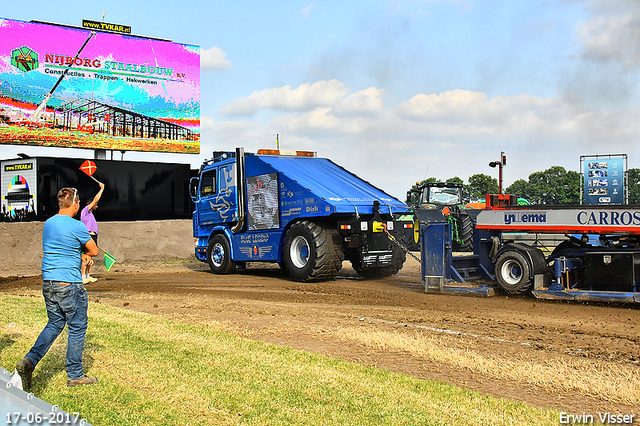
0, 295, 559, 426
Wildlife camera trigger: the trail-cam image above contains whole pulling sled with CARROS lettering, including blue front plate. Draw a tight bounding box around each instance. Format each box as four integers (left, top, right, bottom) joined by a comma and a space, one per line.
420, 195, 640, 303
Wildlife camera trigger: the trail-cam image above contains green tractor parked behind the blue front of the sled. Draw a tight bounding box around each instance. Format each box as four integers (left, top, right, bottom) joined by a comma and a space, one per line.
405, 182, 473, 252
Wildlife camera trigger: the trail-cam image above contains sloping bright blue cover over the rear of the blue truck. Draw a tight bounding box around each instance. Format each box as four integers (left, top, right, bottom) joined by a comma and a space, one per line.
257, 155, 408, 214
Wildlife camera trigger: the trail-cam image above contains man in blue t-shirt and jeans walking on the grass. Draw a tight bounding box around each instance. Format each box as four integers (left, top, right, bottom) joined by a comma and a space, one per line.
16, 188, 98, 392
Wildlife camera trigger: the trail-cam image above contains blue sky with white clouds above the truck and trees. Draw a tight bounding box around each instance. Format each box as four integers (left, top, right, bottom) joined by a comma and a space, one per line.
0, 0, 640, 200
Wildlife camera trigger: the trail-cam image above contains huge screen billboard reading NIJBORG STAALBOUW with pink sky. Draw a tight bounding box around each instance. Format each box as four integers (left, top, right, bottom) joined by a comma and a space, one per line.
0, 18, 200, 154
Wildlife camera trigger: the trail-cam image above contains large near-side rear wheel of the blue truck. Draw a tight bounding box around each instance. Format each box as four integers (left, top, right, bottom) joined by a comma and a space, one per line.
283, 220, 344, 282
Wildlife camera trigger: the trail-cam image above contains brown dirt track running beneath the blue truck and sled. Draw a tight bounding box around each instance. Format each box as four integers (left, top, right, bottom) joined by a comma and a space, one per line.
0, 259, 640, 418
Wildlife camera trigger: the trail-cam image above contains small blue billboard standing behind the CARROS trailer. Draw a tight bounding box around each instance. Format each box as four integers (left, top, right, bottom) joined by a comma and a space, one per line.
580, 155, 626, 205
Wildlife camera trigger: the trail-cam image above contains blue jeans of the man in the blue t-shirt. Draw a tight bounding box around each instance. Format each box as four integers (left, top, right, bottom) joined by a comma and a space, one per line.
26, 281, 88, 380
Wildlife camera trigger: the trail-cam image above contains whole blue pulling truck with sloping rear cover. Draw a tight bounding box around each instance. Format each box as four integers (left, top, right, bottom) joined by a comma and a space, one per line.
190, 148, 408, 282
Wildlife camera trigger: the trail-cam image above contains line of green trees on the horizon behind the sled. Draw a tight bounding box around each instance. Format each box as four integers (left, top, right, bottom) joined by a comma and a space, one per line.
407, 166, 640, 204
